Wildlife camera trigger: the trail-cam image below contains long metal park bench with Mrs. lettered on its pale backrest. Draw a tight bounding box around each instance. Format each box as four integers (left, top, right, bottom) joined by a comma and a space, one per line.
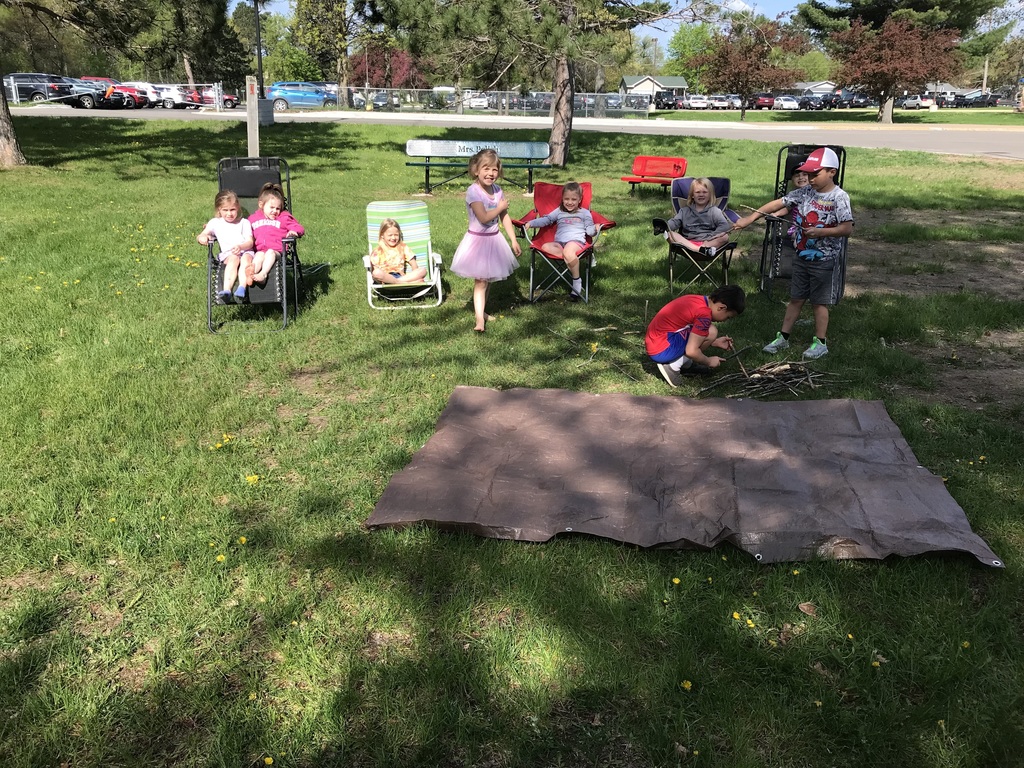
406, 138, 551, 195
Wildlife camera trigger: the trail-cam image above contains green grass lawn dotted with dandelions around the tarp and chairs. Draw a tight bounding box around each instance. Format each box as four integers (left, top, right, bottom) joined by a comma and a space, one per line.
0, 114, 1024, 768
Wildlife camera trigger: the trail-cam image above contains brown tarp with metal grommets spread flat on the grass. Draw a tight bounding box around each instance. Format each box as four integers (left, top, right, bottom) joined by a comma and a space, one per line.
367, 387, 1002, 567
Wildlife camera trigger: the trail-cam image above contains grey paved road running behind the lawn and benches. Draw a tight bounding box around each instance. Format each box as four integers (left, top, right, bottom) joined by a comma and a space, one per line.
14, 106, 1024, 161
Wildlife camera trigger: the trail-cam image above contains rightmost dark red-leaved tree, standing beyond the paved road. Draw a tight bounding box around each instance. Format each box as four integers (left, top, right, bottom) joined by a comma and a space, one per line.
829, 17, 959, 123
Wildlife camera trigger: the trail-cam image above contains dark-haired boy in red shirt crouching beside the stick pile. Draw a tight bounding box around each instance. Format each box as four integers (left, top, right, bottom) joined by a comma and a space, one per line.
644, 286, 746, 387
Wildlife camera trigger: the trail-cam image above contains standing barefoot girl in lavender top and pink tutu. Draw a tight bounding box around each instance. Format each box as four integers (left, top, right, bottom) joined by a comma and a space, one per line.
452, 150, 519, 333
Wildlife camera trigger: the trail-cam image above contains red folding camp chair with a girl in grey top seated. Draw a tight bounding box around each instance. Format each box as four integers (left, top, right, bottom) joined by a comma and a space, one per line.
512, 181, 615, 302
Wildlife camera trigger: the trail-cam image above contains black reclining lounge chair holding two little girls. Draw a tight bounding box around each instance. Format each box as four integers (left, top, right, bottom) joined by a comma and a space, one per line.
206, 158, 302, 333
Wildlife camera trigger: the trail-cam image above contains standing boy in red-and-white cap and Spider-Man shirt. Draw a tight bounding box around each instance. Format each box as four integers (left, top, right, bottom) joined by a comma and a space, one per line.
733, 146, 853, 360
